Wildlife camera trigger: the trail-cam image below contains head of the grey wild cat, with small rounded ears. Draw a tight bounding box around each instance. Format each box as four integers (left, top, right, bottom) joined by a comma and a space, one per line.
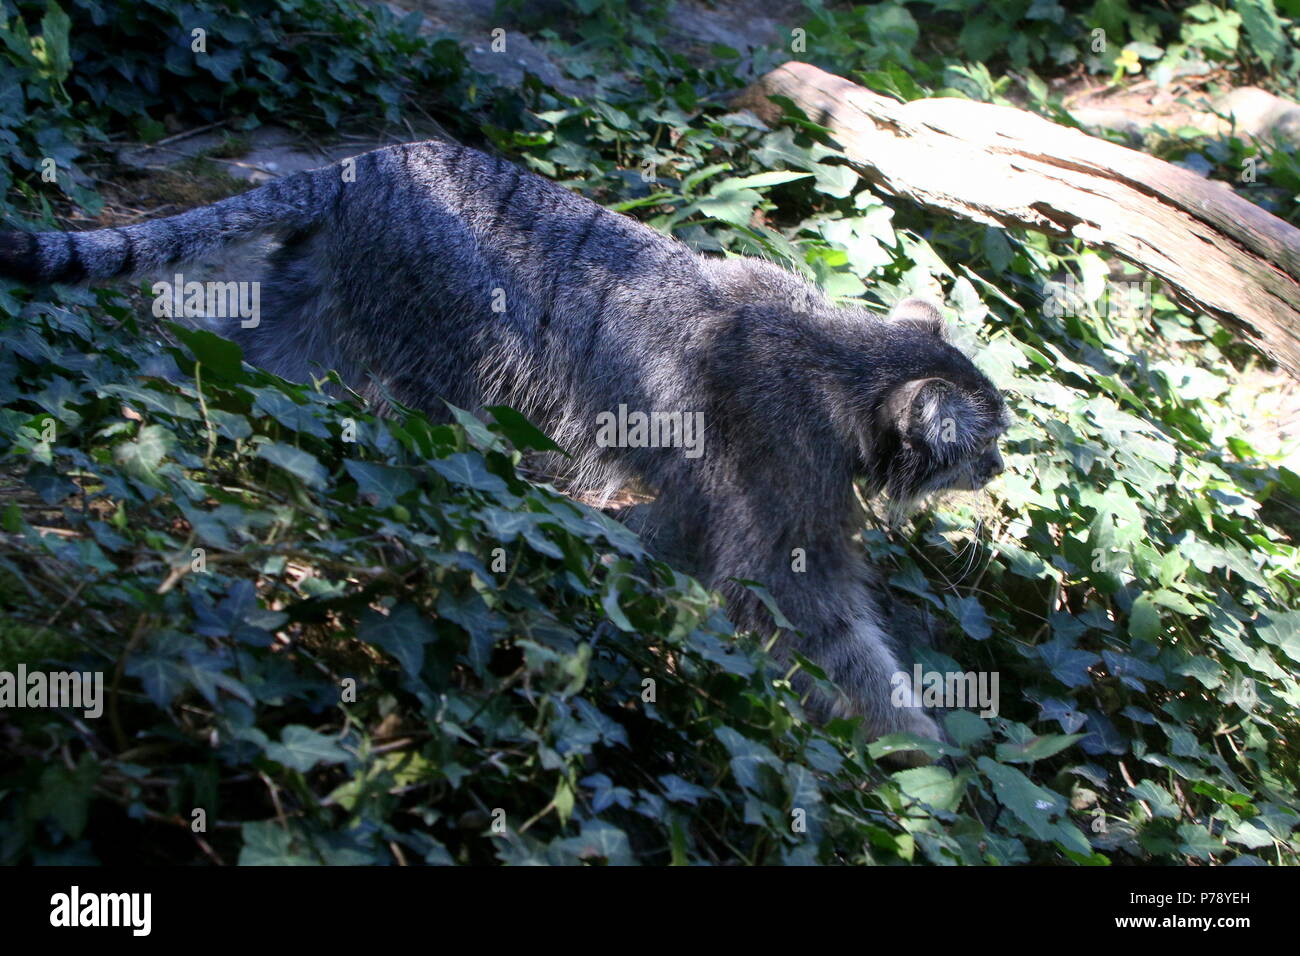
872, 299, 1010, 503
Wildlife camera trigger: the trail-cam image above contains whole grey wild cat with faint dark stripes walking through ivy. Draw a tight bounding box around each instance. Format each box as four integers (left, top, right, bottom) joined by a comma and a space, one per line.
0, 142, 1008, 764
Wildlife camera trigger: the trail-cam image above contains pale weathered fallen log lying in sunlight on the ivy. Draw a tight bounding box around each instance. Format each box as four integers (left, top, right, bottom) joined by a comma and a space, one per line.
736, 62, 1300, 380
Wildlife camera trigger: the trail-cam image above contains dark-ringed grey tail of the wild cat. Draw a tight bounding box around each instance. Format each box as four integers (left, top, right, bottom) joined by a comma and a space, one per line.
0, 166, 342, 285
